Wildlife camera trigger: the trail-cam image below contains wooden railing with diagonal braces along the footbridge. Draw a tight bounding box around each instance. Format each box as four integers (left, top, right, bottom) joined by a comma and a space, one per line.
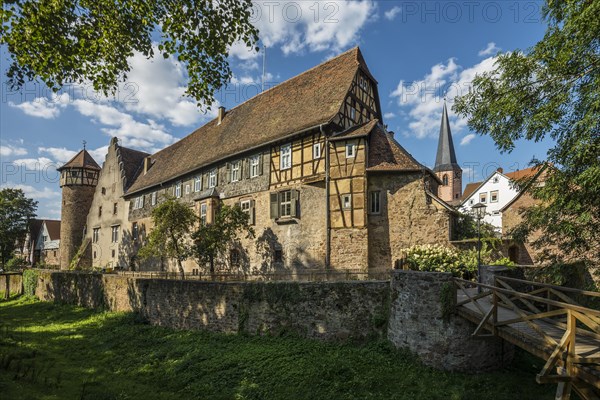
454, 277, 600, 398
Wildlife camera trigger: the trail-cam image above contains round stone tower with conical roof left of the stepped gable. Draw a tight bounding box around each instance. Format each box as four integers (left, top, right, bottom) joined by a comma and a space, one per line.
58, 147, 100, 269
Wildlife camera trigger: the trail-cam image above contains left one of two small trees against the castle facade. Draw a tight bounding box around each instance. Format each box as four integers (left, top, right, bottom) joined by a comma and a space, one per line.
138, 198, 198, 277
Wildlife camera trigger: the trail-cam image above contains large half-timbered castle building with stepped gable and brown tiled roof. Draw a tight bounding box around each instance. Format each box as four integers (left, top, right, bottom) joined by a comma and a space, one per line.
63, 48, 455, 274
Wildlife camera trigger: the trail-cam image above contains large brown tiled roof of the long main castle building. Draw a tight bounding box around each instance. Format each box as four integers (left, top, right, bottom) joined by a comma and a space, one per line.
128, 47, 366, 193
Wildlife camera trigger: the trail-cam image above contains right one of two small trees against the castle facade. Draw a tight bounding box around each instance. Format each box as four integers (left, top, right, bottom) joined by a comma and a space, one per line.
192, 205, 254, 273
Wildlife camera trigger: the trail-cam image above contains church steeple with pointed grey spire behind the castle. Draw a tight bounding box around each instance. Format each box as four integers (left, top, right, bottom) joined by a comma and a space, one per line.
433, 99, 462, 201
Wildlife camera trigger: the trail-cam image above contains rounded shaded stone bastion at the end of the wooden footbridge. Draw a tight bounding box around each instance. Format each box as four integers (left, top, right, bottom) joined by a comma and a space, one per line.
388, 271, 514, 372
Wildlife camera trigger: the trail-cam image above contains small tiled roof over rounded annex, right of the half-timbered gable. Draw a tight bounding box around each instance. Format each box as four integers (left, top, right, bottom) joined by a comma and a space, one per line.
367, 124, 425, 171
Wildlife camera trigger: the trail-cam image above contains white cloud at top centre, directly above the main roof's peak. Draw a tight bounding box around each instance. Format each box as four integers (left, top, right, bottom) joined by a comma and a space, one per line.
254, 0, 376, 54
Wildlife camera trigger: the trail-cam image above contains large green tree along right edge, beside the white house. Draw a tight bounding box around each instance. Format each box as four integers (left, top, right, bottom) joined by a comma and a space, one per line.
454, 0, 600, 266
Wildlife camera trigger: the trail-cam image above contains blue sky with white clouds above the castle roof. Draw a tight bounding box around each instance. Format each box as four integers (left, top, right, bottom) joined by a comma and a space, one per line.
0, 0, 552, 218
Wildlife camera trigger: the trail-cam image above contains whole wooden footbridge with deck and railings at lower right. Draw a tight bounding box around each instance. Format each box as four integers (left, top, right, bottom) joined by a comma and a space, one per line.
454, 277, 600, 400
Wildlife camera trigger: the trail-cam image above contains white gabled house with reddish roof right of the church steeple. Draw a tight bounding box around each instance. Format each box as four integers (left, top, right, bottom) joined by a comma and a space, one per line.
460, 168, 536, 233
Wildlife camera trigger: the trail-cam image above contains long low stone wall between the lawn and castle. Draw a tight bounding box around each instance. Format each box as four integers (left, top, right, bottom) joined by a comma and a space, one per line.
36, 271, 389, 340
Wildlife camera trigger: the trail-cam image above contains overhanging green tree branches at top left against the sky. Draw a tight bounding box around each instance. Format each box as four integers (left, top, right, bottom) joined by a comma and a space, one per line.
0, 0, 258, 105
